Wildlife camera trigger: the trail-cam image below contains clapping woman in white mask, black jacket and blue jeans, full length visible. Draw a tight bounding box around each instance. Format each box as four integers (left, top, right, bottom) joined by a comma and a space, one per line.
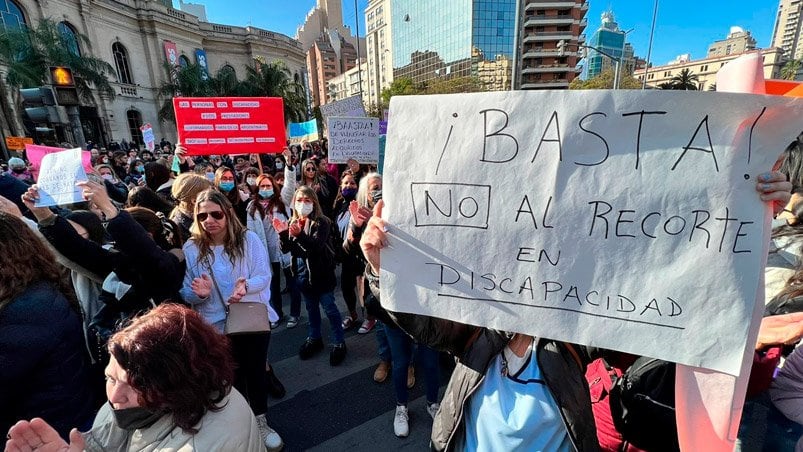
273, 185, 346, 366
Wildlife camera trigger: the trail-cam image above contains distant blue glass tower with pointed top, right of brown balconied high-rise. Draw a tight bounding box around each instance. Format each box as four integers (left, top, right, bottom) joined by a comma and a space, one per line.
586, 11, 635, 78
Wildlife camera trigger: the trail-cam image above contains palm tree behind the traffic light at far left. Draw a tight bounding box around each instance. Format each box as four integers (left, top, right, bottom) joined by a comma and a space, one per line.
0, 19, 114, 102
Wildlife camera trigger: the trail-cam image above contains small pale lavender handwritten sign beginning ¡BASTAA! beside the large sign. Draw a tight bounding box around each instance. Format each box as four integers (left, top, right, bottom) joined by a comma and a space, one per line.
326, 118, 379, 164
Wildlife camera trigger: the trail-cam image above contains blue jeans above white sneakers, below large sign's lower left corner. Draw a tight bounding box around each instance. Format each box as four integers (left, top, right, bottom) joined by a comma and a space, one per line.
385, 327, 440, 405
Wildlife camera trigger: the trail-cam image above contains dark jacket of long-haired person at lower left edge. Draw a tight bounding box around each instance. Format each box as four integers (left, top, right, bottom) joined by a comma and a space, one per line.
0, 282, 94, 439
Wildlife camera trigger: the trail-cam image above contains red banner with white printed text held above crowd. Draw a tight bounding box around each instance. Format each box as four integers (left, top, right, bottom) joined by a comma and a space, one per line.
173, 97, 287, 155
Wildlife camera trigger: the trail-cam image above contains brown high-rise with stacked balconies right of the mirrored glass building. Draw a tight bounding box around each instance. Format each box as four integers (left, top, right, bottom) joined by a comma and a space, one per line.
515, 0, 588, 89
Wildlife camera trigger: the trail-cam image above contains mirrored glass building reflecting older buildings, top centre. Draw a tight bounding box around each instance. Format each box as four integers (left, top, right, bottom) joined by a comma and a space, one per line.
392, 0, 519, 89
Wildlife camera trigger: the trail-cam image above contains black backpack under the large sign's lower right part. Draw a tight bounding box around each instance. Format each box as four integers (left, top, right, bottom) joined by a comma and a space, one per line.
609, 357, 680, 452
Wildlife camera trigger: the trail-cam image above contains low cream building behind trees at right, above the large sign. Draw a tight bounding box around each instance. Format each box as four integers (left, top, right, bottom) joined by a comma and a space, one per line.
633, 47, 784, 90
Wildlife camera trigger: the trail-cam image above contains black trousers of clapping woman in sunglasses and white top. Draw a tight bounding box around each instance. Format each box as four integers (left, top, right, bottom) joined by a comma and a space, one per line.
228, 332, 270, 416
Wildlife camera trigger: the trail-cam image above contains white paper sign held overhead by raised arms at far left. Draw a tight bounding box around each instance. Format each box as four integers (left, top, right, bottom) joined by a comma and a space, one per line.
36, 148, 86, 207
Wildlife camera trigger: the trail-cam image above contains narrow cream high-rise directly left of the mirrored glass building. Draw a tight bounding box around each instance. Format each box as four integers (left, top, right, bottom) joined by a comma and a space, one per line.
363, 0, 393, 105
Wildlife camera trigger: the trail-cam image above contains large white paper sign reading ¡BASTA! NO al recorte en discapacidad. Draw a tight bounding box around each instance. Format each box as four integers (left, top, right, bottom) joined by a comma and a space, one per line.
381, 91, 803, 374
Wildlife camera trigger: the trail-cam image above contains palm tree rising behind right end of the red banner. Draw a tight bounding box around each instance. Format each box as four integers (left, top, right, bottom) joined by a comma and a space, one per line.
242, 61, 307, 122
